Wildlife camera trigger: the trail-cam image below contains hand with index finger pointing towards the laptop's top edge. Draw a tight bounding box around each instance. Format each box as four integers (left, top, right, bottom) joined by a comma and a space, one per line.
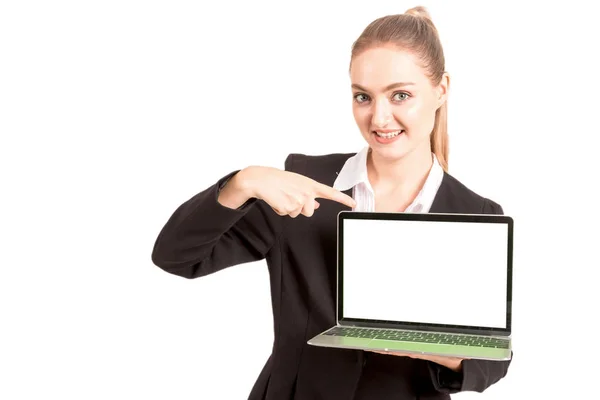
219, 166, 356, 218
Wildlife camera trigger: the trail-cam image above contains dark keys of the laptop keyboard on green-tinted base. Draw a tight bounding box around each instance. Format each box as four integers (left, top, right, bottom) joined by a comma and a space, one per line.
326, 327, 509, 349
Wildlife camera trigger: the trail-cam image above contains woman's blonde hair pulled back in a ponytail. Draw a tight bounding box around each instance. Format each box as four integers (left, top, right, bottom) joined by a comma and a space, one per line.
350, 6, 448, 171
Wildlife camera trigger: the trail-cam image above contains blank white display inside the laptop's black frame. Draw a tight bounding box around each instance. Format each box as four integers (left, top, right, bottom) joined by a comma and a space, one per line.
342, 219, 508, 328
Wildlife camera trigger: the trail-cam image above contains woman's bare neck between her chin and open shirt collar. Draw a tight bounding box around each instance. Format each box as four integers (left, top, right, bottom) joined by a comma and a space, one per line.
367, 148, 433, 192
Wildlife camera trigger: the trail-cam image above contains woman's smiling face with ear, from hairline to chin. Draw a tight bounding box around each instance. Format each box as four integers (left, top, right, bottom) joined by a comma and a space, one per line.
350, 46, 448, 160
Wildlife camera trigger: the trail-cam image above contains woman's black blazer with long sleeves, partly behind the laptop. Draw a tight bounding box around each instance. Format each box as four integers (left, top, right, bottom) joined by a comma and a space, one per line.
152, 154, 510, 400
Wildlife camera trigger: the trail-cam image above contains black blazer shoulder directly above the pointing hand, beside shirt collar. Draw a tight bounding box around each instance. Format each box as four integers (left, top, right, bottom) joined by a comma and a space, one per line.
285, 153, 356, 183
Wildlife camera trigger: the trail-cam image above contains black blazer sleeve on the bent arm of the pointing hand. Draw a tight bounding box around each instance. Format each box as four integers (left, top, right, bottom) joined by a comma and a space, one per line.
151, 155, 292, 279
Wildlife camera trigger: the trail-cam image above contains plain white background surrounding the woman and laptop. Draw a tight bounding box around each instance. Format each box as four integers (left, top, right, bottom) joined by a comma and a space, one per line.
0, 0, 600, 400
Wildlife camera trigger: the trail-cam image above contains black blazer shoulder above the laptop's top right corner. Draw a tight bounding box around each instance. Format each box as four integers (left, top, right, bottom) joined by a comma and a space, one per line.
438, 172, 504, 214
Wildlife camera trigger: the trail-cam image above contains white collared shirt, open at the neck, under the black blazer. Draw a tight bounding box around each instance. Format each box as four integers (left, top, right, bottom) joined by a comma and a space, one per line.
333, 146, 444, 213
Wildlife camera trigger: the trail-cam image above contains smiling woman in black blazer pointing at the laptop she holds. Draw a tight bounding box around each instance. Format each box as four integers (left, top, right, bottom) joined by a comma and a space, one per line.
152, 7, 510, 400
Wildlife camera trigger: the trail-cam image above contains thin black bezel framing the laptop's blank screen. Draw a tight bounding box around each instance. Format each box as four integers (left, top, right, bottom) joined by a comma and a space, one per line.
337, 211, 514, 336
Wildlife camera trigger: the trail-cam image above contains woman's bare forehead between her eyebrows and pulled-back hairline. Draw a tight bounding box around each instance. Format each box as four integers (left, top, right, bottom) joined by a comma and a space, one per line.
350, 46, 429, 91
